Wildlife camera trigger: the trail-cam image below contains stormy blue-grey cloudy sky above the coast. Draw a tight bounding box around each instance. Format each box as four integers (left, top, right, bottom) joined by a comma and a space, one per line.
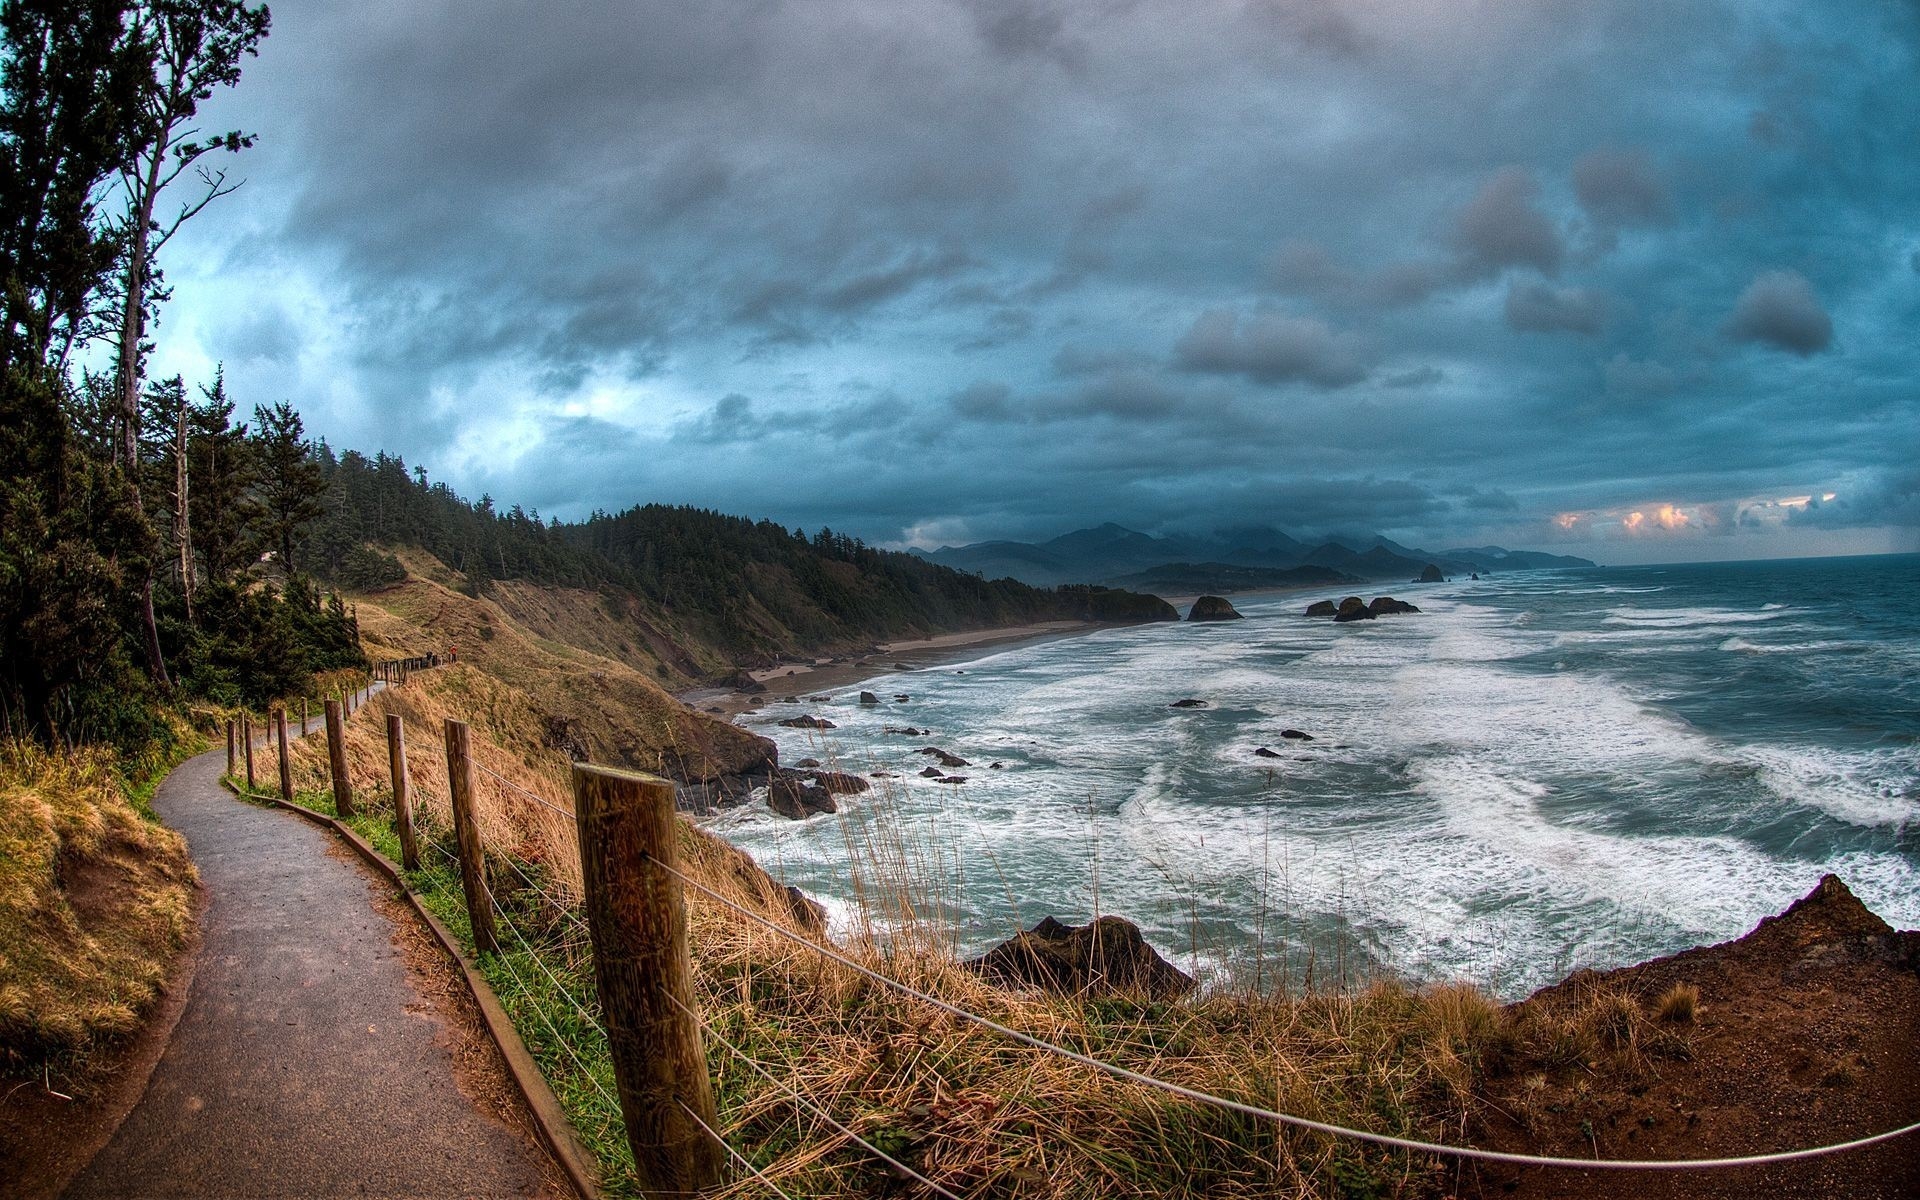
156, 0, 1920, 563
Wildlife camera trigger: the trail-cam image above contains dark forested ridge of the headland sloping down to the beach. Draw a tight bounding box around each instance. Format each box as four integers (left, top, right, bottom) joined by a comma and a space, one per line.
296, 445, 1175, 662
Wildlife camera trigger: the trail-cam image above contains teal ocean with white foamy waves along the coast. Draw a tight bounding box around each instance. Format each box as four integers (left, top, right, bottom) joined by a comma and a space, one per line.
708, 555, 1920, 996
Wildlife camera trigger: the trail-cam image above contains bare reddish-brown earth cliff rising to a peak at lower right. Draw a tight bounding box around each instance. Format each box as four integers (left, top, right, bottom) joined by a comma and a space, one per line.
1478, 876, 1920, 1200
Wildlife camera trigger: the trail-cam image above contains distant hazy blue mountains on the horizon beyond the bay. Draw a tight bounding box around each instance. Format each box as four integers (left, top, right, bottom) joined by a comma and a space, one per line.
914, 522, 1594, 593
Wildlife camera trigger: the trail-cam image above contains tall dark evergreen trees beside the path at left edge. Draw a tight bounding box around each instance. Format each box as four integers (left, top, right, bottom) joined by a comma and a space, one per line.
0, 0, 363, 745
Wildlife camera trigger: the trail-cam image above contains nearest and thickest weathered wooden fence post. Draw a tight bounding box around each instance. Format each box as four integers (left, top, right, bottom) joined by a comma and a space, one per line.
574, 762, 724, 1194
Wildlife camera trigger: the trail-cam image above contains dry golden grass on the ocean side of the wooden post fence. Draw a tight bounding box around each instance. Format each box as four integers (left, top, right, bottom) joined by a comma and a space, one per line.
278, 668, 1543, 1198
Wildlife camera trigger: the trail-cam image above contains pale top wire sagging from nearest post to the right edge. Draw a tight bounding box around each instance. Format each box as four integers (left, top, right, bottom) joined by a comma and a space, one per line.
649, 856, 1920, 1171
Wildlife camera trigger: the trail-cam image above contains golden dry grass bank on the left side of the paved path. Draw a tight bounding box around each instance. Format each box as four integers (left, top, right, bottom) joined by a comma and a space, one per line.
0, 743, 196, 1071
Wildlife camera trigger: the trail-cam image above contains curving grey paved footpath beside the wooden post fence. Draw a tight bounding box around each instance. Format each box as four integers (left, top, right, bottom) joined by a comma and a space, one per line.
67, 722, 547, 1196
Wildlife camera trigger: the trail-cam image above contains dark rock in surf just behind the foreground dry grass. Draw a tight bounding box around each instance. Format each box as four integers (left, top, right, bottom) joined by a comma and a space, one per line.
960, 916, 1194, 998
